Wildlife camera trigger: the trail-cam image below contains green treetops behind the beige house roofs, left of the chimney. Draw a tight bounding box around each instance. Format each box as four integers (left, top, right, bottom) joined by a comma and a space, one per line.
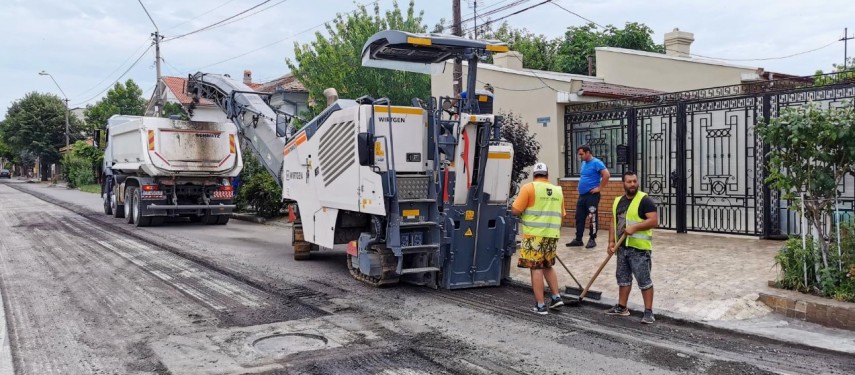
484, 22, 665, 74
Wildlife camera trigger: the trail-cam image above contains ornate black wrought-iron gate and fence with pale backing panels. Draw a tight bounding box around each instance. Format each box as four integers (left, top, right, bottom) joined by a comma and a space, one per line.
565, 74, 855, 238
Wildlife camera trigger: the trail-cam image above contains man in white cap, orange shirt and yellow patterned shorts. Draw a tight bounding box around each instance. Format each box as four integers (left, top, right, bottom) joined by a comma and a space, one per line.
512, 163, 564, 315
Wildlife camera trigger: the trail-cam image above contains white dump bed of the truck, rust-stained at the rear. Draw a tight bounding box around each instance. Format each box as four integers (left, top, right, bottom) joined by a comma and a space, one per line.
104, 116, 243, 177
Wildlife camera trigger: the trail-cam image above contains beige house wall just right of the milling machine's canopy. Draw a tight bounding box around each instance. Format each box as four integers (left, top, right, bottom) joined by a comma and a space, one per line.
431, 63, 581, 181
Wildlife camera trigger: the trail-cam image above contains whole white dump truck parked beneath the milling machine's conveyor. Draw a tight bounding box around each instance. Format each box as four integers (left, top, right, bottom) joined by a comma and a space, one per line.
101, 115, 243, 227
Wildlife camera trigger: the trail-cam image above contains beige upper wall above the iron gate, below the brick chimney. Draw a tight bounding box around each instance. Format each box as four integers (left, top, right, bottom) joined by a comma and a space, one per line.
596, 48, 757, 92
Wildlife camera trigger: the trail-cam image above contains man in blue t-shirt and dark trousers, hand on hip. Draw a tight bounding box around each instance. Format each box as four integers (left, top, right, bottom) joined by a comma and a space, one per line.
567, 145, 611, 249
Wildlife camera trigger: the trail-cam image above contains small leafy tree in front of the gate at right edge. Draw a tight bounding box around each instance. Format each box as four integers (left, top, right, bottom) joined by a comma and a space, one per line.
757, 103, 855, 298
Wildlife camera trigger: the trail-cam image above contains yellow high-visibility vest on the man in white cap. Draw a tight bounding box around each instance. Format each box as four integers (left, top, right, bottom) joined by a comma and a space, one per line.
521, 181, 564, 238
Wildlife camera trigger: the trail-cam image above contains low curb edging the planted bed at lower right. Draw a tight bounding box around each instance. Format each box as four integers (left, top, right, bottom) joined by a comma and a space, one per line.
760, 281, 855, 331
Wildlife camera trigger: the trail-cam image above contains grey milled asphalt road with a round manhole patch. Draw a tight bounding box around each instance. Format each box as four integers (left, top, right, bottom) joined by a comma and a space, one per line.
0, 182, 855, 374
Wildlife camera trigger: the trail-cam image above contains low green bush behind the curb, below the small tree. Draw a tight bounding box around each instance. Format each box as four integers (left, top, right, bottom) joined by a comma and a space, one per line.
775, 224, 855, 302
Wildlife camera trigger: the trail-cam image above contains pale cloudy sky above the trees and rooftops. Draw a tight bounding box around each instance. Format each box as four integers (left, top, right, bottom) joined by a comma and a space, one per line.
0, 0, 855, 119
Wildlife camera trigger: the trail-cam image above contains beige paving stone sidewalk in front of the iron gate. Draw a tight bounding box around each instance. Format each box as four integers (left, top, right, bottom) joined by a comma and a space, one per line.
511, 227, 783, 321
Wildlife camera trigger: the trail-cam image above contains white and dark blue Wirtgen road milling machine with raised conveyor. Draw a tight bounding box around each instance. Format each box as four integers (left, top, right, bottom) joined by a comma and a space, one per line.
188, 31, 517, 289
